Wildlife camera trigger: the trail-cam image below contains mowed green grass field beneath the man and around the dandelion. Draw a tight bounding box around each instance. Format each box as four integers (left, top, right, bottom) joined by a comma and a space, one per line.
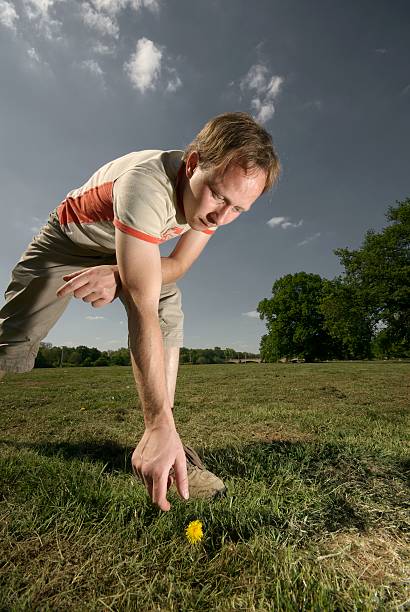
0, 362, 410, 612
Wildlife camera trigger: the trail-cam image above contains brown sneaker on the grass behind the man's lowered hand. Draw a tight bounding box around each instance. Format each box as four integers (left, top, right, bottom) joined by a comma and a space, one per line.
170, 444, 226, 499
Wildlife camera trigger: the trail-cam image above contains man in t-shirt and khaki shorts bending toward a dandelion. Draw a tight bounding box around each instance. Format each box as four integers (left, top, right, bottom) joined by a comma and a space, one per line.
0, 113, 279, 511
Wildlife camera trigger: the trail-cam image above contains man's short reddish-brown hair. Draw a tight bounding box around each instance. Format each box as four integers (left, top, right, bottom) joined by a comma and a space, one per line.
182, 112, 280, 192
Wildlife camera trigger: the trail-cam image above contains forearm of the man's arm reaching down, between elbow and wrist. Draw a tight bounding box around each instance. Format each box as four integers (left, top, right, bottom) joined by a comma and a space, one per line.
128, 301, 175, 427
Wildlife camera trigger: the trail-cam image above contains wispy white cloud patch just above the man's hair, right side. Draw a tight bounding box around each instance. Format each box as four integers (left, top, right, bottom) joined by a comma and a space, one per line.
240, 63, 284, 123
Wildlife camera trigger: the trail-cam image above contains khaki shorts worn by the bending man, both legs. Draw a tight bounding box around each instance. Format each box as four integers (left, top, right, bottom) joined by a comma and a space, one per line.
0, 212, 184, 372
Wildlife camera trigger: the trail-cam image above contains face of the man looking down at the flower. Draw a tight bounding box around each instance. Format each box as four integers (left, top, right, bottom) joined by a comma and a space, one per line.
183, 152, 266, 231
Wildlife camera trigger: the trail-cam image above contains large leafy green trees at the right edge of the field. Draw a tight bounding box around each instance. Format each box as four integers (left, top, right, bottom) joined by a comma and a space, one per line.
257, 199, 410, 362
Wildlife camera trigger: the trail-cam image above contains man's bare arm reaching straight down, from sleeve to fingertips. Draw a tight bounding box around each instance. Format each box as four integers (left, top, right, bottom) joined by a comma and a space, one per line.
115, 230, 188, 510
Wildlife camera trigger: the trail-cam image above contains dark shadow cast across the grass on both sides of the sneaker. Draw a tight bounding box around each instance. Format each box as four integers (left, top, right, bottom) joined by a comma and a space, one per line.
0, 440, 407, 541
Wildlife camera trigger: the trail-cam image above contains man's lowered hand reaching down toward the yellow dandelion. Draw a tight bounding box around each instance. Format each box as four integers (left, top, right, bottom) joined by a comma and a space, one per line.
131, 424, 189, 512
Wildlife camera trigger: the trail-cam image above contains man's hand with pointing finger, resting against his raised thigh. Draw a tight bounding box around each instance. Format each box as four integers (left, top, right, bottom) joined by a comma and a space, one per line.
57, 265, 121, 308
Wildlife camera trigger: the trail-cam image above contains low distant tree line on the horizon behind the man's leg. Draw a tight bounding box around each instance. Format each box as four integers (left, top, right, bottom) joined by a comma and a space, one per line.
34, 342, 259, 368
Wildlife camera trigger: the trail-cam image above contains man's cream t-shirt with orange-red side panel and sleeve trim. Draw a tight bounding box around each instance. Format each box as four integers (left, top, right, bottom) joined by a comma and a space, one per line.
57, 151, 213, 253
